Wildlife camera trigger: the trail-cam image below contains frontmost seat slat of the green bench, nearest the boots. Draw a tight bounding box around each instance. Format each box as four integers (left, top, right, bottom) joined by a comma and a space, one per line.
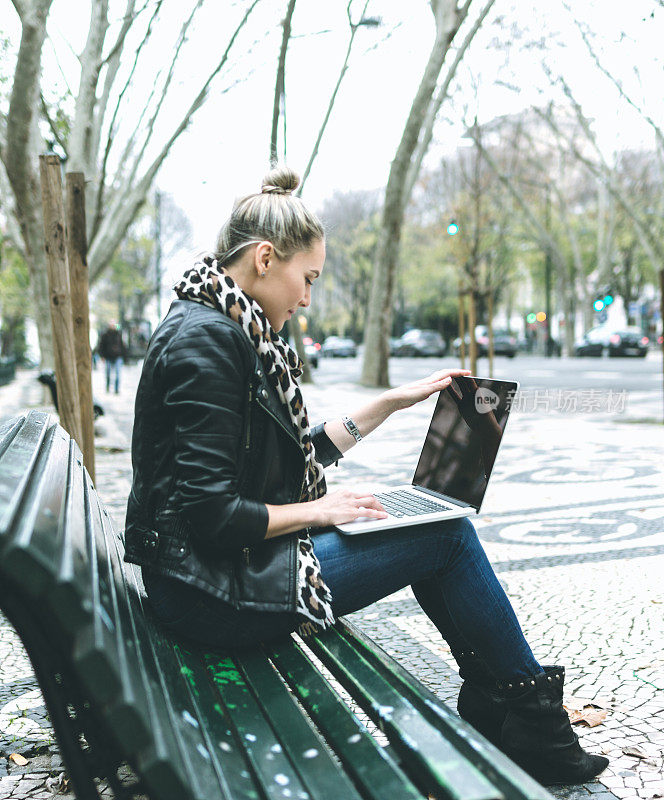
338, 620, 551, 800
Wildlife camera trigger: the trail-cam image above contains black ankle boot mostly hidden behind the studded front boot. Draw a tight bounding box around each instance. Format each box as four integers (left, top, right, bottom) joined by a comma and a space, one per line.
457, 651, 507, 747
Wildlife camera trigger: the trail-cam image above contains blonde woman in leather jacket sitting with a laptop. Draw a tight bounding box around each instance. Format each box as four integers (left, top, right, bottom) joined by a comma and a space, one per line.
125, 169, 608, 782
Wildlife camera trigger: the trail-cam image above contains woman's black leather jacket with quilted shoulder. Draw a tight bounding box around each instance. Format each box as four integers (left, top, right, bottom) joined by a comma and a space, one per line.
125, 300, 342, 611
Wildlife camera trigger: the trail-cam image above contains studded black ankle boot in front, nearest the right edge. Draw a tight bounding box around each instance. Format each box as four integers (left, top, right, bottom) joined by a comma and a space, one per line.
500, 667, 609, 784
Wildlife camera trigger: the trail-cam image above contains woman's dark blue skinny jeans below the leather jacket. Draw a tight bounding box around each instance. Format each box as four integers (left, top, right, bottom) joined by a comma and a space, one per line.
143, 518, 542, 681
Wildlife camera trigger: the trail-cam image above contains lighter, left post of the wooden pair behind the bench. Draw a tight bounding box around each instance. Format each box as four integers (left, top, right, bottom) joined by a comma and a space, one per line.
39, 156, 83, 449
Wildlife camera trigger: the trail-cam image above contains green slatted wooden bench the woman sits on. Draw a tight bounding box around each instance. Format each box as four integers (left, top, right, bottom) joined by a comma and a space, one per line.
0, 411, 550, 800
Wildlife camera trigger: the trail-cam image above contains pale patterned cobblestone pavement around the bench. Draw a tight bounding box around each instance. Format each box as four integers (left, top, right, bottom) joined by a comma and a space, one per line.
0, 365, 664, 800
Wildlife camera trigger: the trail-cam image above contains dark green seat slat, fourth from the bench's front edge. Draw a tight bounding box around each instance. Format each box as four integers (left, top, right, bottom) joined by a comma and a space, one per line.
236, 650, 361, 800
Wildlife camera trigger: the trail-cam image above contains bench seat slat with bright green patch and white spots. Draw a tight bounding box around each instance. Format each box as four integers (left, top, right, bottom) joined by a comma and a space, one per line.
206, 656, 306, 800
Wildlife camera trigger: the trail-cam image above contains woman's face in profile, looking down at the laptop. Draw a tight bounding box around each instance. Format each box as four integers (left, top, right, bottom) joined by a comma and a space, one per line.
254, 239, 325, 331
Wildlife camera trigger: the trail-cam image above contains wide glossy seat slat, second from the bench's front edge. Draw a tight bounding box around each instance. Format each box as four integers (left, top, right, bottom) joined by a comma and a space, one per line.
310, 628, 503, 800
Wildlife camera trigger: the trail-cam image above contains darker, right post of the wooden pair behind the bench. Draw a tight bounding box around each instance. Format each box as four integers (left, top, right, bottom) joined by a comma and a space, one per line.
65, 172, 95, 483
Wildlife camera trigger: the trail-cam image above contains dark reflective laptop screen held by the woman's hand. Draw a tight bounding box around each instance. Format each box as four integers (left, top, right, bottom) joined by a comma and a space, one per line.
413, 377, 518, 510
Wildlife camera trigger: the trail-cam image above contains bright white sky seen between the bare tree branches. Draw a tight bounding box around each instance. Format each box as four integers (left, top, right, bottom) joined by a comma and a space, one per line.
0, 0, 664, 270
